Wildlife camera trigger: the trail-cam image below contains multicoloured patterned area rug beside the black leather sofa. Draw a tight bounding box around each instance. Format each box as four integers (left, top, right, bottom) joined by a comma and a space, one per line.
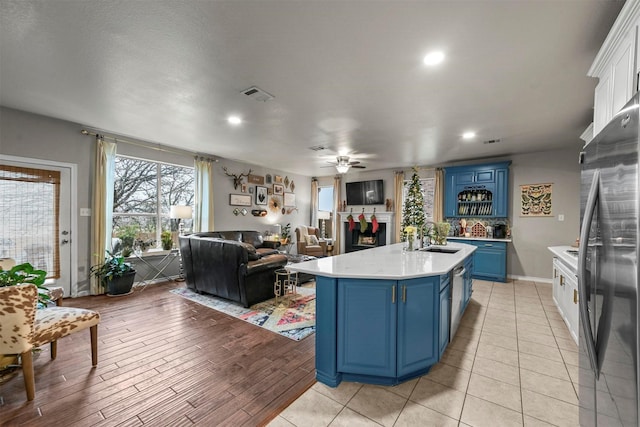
170, 285, 316, 341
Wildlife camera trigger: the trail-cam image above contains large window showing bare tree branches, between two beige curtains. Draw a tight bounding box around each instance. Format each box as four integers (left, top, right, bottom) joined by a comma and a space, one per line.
112, 156, 194, 250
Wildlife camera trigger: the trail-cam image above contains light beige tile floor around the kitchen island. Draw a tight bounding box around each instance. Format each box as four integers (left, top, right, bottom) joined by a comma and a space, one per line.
269, 280, 578, 427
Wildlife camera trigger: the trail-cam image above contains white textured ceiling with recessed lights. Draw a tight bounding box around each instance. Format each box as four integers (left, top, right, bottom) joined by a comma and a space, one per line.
0, 0, 623, 176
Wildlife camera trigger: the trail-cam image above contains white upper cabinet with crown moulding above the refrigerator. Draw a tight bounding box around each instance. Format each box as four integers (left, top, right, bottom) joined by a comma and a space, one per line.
587, 0, 640, 135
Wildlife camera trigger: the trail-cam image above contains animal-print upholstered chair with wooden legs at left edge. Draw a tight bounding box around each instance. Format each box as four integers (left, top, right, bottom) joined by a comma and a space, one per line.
0, 285, 100, 400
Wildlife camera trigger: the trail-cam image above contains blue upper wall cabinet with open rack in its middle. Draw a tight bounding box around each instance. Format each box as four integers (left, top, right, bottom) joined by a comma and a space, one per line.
444, 162, 511, 218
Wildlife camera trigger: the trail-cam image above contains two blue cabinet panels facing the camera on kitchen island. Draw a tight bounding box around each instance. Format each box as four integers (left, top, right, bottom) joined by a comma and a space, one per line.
337, 276, 440, 384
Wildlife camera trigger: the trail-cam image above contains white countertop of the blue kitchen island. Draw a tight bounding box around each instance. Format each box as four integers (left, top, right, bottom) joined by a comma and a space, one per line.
286, 242, 476, 280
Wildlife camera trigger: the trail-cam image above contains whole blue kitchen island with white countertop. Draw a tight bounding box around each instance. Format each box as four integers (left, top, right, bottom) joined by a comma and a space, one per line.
287, 243, 476, 387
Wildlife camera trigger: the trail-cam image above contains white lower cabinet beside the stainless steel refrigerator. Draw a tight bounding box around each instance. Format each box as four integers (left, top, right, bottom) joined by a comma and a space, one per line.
553, 257, 579, 344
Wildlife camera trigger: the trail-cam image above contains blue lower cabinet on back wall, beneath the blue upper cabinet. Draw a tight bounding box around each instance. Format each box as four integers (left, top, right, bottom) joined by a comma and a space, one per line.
455, 239, 507, 282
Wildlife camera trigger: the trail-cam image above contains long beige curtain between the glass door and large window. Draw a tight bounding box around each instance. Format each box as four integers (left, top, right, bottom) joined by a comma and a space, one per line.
90, 135, 116, 295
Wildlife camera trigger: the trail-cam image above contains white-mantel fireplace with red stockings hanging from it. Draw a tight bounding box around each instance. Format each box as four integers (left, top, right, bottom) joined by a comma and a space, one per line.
340, 212, 393, 253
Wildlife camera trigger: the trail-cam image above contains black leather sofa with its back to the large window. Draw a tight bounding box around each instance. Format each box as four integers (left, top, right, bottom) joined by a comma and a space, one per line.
180, 231, 287, 307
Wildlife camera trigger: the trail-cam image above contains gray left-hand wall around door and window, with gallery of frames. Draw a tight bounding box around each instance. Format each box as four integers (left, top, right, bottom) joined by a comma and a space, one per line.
0, 107, 311, 292
